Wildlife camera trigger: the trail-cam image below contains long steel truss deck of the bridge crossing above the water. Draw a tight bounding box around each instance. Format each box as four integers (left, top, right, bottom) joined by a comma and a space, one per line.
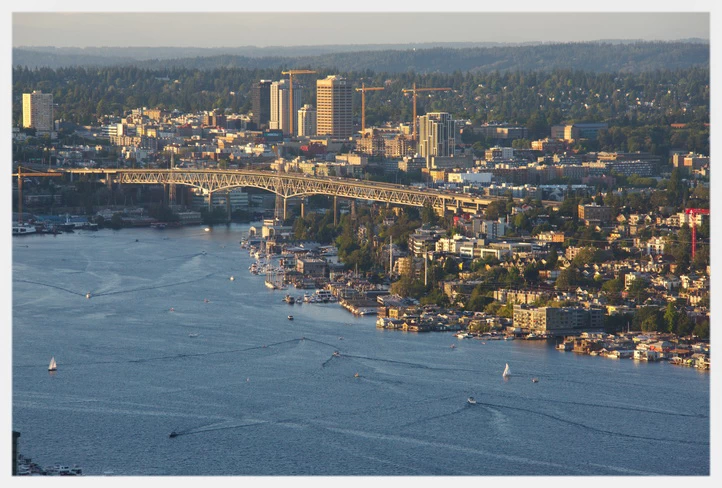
35, 168, 558, 216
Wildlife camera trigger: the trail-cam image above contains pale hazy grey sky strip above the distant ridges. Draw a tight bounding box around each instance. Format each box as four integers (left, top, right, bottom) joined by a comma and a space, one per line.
12, 11, 710, 47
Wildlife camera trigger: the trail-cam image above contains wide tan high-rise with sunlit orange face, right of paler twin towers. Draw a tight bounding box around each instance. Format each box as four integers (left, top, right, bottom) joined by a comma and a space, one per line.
316, 75, 353, 137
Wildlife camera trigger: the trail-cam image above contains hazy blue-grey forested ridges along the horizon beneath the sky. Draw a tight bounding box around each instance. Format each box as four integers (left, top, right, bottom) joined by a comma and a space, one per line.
12, 39, 709, 73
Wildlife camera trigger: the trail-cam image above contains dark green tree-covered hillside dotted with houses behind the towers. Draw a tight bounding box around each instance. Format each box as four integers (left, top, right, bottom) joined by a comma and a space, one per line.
13, 66, 710, 143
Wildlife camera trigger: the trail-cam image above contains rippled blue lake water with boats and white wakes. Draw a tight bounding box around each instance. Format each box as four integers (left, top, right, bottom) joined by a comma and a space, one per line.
12, 224, 710, 476
